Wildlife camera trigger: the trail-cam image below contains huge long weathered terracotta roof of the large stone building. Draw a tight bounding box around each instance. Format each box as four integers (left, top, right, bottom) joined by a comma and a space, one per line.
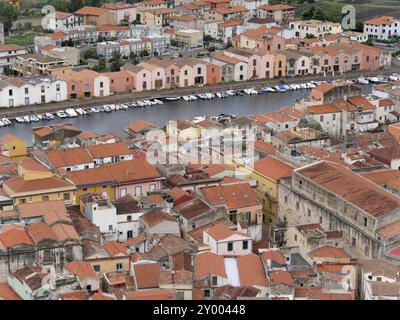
296, 161, 400, 217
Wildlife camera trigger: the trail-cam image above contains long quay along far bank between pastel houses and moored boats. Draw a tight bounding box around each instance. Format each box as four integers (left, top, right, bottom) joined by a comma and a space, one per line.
0, 65, 400, 119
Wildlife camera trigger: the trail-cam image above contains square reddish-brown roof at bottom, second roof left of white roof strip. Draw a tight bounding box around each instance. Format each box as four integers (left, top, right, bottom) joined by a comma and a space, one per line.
132, 263, 161, 290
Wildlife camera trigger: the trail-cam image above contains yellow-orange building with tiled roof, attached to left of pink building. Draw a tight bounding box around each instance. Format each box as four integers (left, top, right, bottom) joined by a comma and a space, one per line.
66, 167, 115, 205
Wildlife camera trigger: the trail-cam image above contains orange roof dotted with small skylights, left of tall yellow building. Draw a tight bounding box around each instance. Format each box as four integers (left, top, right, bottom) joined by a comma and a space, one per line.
202, 183, 260, 210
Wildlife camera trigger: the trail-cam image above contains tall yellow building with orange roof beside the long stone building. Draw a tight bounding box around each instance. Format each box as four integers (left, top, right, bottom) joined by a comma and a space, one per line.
247, 156, 294, 223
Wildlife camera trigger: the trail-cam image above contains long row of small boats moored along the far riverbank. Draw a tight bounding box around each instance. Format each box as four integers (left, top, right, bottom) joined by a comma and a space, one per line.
0, 73, 400, 127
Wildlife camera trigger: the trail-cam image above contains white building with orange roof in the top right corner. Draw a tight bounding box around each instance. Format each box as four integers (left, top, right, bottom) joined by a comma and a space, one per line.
364, 16, 400, 40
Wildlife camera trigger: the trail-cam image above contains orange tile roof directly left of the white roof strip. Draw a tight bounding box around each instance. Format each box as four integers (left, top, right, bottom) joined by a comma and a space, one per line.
194, 252, 228, 279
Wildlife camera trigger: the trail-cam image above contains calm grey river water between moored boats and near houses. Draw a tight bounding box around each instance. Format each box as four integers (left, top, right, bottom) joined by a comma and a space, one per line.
0, 86, 371, 144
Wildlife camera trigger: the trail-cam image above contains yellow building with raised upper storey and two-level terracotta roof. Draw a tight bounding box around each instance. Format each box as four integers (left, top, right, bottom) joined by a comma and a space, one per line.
3, 158, 76, 205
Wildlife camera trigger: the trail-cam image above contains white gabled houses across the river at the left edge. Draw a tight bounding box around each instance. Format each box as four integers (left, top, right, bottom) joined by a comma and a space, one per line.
0, 76, 67, 108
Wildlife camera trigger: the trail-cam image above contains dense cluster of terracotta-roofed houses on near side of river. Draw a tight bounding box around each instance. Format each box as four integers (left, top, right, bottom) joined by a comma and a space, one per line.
0, 77, 400, 300
